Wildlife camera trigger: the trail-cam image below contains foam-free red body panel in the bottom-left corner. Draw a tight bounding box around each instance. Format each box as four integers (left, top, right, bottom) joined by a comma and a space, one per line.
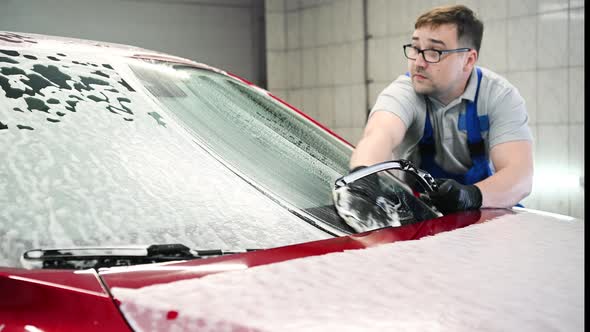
0, 268, 130, 332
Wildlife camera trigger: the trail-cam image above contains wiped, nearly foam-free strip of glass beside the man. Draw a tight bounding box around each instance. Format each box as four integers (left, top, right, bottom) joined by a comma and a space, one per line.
131, 63, 437, 232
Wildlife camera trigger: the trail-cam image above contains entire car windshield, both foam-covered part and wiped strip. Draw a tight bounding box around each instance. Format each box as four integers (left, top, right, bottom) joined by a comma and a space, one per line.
0, 49, 440, 266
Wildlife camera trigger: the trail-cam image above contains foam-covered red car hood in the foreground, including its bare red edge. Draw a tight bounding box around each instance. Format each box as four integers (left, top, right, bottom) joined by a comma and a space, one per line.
101, 209, 584, 331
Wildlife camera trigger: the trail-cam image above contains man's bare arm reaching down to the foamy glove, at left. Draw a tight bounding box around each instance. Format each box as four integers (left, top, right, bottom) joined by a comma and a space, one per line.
350, 111, 407, 169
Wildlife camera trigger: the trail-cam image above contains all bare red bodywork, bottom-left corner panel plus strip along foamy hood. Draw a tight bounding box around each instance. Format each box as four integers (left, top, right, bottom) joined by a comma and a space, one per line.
0, 210, 500, 332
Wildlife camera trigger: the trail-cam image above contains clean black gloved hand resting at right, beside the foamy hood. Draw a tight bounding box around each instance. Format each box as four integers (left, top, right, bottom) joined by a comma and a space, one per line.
421, 179, 482, 214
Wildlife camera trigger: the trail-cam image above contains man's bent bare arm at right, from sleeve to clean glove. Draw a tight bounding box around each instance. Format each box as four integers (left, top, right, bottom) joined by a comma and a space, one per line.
475, 141, 533, 208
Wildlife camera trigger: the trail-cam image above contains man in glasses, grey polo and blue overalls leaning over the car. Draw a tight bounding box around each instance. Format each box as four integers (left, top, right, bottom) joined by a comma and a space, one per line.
334, 5, 533, 231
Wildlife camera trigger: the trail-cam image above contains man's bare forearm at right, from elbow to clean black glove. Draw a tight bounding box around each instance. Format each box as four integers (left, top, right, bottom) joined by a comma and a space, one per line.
476, 167, 533, 208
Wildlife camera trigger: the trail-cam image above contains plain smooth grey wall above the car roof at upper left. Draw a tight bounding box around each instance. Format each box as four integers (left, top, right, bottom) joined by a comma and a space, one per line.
0, 0, 266, 86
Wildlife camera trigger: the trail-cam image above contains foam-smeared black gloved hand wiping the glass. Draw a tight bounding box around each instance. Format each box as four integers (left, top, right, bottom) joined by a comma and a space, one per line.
332, 166, 401, 232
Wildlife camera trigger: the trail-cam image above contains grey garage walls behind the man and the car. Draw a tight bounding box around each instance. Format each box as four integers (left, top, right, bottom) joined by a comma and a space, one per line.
0, 0, 585, 218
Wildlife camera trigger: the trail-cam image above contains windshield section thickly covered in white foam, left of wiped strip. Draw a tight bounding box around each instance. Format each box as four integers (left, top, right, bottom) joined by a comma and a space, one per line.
0, 50, 331, 266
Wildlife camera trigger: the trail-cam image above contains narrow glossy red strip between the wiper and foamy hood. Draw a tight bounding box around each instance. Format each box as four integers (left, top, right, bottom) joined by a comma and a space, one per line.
99, 209, 514, 288
